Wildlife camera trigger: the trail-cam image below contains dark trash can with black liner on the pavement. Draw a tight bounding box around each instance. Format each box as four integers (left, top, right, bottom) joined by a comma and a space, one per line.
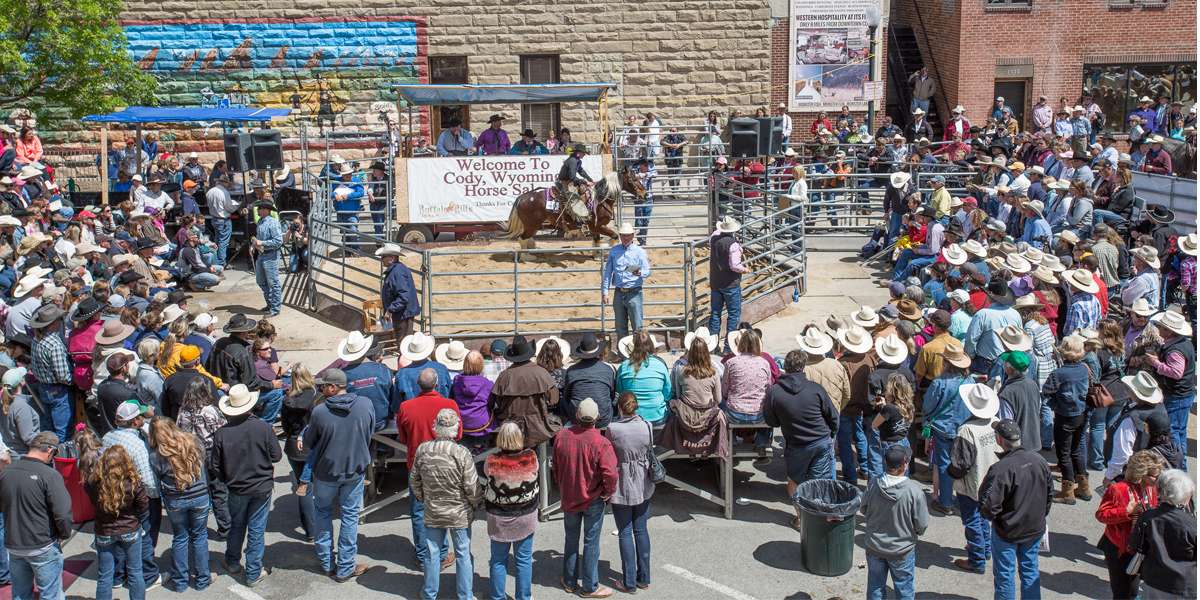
792, 479, 863, 577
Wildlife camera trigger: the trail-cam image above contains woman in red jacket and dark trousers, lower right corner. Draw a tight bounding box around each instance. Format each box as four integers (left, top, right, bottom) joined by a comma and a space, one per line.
1096, 450, 1166, 600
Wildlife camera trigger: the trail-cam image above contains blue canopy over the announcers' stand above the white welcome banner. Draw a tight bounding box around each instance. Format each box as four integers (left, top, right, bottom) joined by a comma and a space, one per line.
391, 83, 617, 107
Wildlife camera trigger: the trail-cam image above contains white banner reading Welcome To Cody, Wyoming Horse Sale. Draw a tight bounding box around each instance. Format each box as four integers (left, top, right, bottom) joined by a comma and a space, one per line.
408, 155, 604, 223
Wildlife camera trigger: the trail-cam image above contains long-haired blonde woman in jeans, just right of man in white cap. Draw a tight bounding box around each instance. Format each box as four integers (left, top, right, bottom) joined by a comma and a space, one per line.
143, 417, 212, 592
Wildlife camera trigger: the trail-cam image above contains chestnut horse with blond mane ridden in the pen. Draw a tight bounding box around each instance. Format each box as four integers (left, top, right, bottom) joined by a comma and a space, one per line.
500, 167, 646, 248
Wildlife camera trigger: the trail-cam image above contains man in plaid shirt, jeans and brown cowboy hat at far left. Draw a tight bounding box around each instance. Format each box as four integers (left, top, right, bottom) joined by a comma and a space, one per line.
30, 304, 74, 442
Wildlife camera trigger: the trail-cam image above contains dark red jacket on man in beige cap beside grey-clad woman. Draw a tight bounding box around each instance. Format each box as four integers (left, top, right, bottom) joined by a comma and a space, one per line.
551, 425, 617, 512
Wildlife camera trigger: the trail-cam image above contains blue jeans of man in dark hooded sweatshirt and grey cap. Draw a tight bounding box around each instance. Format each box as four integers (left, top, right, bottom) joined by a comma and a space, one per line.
312, 475, 362, 577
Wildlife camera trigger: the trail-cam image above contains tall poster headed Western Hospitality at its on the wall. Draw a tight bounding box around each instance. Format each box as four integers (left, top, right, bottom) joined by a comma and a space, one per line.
788, 0, 880, 112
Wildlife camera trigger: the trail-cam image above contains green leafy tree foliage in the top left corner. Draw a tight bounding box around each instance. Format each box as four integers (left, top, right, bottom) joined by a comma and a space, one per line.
0, 0, 157, 119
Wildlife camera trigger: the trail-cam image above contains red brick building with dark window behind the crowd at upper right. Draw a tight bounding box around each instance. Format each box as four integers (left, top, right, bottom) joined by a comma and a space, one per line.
889, 0, 1196, 138
